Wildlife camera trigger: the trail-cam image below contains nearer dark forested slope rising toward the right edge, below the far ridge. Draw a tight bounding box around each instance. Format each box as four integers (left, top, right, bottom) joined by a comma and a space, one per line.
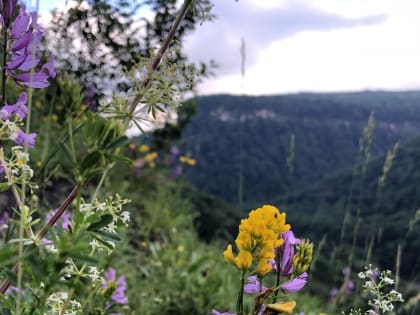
271, 137, 420, 279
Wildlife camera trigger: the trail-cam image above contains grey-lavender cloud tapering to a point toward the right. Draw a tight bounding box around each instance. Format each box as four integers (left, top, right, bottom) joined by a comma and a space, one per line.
185, 0, 387, 75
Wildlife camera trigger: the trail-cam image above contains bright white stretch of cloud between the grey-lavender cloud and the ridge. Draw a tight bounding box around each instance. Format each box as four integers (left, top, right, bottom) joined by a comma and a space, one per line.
192, 0, 420, 94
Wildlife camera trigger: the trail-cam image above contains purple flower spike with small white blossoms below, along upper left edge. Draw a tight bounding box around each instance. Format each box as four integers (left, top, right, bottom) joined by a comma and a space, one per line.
0, 0, 56, 186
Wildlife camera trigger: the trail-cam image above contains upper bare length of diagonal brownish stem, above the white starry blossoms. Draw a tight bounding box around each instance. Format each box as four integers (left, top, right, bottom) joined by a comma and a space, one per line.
128, 0, 192, 117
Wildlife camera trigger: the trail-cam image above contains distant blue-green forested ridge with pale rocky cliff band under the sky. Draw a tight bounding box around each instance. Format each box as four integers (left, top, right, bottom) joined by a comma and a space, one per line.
183, 92, 420, 207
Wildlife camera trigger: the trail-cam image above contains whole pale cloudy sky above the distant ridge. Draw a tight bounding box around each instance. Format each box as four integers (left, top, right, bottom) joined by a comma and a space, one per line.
32, 0, 420, 95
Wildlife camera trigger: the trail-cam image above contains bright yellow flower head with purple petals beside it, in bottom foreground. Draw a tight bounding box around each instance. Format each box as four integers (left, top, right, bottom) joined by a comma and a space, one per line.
217, 205, 313, 315
